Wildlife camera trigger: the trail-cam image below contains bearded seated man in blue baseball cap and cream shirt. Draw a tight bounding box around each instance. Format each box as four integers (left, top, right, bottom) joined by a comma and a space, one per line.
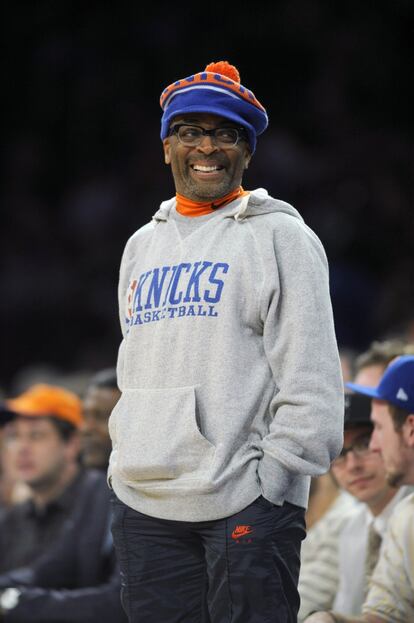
306, 355, 414, 623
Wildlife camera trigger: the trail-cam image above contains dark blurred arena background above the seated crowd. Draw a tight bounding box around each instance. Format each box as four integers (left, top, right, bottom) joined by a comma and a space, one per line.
0, 0, 414, 391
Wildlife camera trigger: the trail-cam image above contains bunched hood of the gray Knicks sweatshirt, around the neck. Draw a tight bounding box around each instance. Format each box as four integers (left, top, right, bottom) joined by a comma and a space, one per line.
152, 188, 303, 224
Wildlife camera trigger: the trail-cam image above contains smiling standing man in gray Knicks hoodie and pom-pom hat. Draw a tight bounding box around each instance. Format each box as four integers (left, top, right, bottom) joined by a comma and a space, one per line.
109, 61, 343, 623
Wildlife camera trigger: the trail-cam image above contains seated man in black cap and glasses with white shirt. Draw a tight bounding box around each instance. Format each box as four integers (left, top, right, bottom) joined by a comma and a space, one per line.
331, 394, 412, 615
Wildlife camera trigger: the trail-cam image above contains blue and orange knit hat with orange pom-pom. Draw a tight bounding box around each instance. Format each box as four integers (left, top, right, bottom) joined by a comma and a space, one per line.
160, 61, 268, 153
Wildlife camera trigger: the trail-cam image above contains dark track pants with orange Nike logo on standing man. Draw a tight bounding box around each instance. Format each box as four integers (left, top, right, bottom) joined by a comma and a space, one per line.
112, 495, 305, 623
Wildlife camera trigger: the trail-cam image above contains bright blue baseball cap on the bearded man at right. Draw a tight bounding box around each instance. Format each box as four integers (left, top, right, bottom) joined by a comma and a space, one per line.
346, 355, 414, 413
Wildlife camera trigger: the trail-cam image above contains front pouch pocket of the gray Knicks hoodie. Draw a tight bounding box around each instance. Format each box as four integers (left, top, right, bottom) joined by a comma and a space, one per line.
113, 387, 215, 487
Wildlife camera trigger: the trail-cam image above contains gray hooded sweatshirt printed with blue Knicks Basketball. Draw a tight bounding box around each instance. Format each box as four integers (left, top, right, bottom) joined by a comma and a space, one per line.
109, 189, 344, 521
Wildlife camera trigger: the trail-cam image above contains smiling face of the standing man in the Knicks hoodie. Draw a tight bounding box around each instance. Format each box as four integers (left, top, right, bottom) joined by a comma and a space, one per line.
163, 113, 251, 201
